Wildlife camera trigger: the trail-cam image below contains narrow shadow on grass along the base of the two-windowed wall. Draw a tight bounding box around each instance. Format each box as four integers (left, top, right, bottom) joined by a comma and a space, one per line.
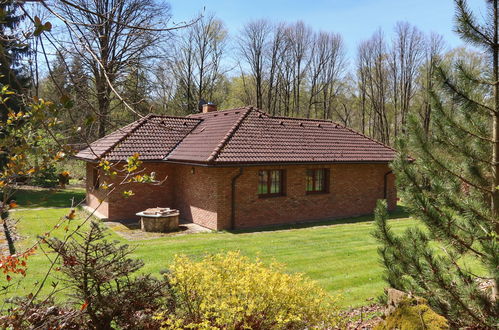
227, 205, 409, 234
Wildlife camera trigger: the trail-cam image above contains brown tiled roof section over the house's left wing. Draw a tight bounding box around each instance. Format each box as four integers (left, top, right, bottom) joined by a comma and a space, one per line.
76, 115, 201, 161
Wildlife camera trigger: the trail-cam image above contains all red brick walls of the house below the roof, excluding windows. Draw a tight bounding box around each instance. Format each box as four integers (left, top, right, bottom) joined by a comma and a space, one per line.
87, 163, 396, 230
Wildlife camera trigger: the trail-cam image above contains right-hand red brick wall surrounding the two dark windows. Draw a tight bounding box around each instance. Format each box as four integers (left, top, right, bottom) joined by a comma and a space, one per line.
219, 164, 396, 228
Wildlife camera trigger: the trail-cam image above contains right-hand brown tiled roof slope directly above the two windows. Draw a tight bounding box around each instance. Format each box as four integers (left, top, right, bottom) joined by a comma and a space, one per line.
211, 111, 395, 163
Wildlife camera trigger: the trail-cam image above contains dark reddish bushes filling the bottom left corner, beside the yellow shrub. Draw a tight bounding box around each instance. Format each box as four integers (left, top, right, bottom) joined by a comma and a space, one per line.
0, 222, 170, 330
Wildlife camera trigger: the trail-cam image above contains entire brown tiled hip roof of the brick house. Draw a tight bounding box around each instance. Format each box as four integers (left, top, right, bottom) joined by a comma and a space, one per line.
78, 107, 396, 165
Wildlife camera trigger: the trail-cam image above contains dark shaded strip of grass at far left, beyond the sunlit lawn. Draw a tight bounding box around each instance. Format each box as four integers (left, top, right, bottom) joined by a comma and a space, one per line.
12, 188, 85, 208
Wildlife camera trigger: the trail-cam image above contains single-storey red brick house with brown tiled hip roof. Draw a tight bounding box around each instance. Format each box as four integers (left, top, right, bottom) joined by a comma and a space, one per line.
76, 105, 396, 230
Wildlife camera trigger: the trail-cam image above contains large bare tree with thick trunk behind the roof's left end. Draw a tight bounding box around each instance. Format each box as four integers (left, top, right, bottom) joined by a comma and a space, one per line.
52, 0, 169, 137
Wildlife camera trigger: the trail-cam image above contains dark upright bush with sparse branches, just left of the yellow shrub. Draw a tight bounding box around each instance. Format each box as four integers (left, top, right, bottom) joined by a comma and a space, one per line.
48, 222, 168, 329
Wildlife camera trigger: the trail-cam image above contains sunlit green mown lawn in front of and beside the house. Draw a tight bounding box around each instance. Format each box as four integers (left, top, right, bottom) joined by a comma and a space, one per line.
7, 188, 415, 307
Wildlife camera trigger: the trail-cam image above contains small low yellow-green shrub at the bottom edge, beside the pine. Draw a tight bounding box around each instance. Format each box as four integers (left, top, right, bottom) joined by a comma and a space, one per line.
374, 298, 449, 330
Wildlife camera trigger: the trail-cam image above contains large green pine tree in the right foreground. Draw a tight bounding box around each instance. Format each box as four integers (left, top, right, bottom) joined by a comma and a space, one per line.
375, 0, 499, 328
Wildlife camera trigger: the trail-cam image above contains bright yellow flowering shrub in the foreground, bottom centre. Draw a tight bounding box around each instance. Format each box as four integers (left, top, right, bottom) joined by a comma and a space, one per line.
157, 252, 340, 329
